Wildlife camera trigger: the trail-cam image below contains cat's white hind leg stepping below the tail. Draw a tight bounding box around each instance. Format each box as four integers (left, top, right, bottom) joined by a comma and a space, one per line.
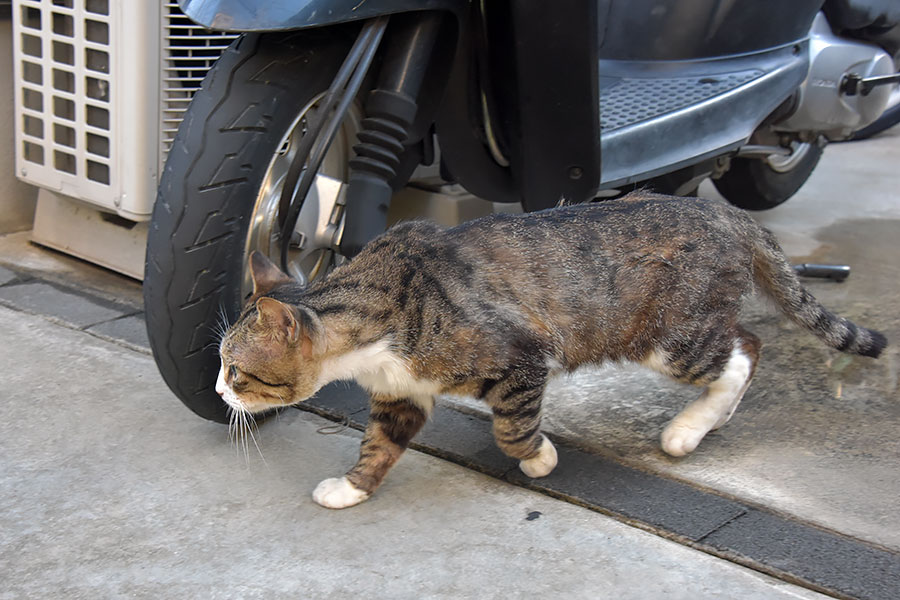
660, 329, 760, 456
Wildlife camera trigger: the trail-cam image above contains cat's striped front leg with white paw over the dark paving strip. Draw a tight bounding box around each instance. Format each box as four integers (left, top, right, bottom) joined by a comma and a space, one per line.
480, 364, 557, 477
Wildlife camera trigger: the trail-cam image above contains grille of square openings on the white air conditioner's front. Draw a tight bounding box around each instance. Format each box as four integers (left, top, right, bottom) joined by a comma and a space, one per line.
15, 0, 116, 186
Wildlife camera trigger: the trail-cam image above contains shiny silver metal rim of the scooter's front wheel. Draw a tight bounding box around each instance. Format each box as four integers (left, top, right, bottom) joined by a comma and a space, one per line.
241, 92, 361, 298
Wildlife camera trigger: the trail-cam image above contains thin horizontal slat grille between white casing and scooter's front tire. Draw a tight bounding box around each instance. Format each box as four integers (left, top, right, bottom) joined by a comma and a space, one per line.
160, 1, 237, 166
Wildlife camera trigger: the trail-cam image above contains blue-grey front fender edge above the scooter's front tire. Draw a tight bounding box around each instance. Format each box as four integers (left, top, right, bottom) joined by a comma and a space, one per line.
178, 0, 467, 32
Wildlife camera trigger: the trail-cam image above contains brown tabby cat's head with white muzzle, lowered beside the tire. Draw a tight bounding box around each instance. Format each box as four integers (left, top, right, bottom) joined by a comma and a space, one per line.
216, 252, 324, 413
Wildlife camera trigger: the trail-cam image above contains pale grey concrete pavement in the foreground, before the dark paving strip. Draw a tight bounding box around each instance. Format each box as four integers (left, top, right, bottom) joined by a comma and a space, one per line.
0, 307, 820, 599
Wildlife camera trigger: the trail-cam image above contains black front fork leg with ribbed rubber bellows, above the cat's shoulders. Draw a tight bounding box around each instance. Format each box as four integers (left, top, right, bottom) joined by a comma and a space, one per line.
340, 13, 444, 258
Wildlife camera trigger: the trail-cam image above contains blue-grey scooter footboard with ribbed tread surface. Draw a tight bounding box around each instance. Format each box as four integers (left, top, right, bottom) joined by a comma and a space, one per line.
598, 42, 808, 187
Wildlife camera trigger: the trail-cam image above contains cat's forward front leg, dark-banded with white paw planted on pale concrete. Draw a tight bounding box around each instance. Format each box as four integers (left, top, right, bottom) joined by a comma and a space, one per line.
313, 396, 434, 508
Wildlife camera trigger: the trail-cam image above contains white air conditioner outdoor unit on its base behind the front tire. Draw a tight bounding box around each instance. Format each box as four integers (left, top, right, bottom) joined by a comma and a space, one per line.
13, 0, 236, 278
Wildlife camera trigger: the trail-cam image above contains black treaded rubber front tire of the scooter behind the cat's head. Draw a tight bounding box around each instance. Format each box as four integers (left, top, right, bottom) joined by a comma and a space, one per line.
143, 30, 352, 423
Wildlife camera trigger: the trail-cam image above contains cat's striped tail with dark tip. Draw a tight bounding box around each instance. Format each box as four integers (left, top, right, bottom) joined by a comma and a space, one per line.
753, 228, 887, 358
